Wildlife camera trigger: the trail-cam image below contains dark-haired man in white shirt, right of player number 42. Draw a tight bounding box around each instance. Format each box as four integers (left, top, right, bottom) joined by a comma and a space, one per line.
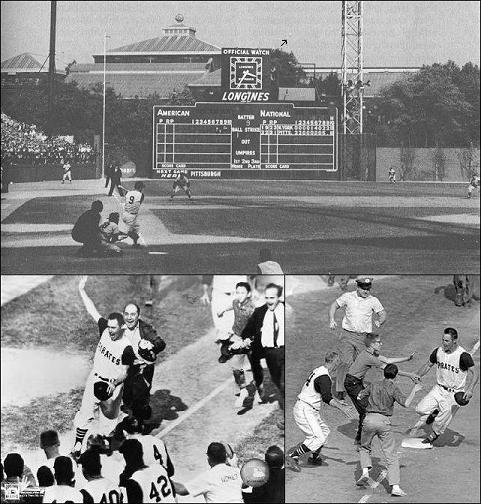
173, 443, 244, 503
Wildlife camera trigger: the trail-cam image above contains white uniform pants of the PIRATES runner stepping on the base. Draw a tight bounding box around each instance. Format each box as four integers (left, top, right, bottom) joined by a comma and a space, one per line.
416, 385, 459, 436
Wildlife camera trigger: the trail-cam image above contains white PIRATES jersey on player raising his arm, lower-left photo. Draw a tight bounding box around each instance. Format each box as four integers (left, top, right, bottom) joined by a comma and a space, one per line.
92, 319, 132, 379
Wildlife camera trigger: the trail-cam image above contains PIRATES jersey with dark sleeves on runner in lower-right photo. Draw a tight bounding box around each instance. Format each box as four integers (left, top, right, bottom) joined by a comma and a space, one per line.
429, 346, 474, 392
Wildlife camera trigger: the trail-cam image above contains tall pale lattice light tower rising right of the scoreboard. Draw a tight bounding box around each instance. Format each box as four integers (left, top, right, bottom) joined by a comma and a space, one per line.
341, 1, 364, 135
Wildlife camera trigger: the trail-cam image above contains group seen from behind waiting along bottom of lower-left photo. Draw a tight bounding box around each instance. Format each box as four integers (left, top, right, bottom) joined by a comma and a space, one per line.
0, 420, 285, 504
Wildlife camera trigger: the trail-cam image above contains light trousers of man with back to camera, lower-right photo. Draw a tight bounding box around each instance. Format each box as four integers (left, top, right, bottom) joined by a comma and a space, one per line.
359, 413, 400, 485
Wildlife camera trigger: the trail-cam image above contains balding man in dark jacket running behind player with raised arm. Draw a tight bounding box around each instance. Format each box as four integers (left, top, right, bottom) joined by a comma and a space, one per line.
123, 303, 165, 425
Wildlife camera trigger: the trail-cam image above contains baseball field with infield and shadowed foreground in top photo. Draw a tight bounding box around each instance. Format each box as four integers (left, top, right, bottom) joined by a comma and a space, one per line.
1, 179, 479, 274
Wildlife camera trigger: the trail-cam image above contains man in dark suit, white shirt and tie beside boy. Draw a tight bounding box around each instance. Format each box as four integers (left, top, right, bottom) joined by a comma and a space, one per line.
241, 283, 285, 409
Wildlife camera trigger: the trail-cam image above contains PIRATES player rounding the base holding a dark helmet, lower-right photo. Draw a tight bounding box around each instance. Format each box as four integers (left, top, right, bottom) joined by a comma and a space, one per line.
411, 327, 479, 446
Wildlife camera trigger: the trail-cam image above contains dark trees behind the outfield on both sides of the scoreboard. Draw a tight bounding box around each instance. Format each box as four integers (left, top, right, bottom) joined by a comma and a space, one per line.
1, 49, 480, 171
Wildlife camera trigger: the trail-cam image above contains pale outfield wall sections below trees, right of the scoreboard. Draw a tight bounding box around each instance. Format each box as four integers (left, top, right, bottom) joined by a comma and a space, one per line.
376, 147, 479, 182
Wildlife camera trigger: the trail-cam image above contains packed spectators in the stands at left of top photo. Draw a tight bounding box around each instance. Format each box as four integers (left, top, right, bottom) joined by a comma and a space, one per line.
1, 112, 95, 165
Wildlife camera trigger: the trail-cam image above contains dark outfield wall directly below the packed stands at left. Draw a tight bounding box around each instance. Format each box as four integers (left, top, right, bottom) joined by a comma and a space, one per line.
3, 162, 99, 182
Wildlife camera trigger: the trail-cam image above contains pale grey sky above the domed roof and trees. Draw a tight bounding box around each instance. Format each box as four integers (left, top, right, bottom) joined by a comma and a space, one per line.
1, 1, 480, 68
